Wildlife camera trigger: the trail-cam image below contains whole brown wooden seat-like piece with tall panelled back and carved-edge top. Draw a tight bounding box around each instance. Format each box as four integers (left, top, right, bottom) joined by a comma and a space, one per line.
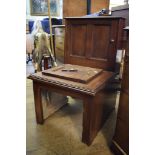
29, 16, 124, 145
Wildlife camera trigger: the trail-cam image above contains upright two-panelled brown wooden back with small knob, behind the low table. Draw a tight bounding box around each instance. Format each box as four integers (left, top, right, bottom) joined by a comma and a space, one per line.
64, 17, 123, 71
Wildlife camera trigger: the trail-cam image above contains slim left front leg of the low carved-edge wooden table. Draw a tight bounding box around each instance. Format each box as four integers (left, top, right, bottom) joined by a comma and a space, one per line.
33, 81, 44, 124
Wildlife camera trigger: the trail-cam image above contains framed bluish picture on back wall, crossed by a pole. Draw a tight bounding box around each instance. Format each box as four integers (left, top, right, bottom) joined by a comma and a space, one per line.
30, 0, 60, 16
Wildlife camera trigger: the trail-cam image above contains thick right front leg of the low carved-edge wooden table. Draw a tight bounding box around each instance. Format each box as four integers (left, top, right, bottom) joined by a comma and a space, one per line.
82, 91, 104, 146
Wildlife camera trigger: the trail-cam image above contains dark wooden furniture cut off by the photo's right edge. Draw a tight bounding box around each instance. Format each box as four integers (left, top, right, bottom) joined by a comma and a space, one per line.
111, 28, 129, 155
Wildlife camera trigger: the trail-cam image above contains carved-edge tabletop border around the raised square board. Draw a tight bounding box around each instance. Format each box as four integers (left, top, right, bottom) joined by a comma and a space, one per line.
28, 68, 115, 96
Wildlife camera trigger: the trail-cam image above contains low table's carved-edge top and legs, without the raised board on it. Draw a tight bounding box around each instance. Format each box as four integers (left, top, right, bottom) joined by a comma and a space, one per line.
29, 66, 114, 145
